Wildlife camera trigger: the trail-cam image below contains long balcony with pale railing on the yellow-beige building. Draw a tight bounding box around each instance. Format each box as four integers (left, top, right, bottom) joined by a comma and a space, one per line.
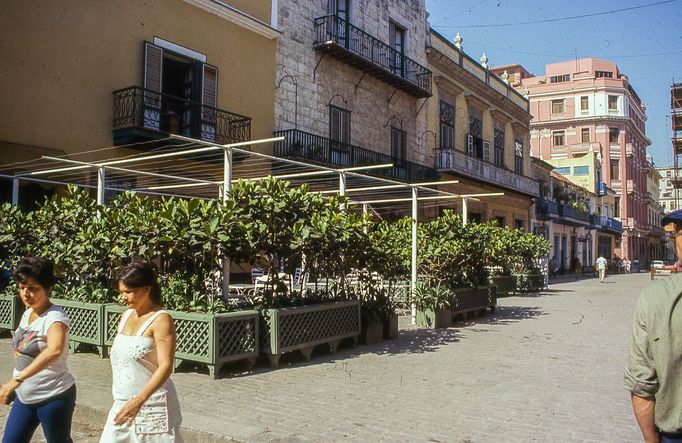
437, 148, 540, 197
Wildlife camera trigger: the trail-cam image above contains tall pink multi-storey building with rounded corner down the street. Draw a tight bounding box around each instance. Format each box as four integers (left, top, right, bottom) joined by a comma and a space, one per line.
491, 58, 653, 264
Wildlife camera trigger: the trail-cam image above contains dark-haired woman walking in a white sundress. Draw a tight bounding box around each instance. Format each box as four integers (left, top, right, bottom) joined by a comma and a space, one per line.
100, 262, 182, 443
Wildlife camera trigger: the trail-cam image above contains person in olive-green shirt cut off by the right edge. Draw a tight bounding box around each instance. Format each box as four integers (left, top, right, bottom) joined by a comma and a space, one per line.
625, 210, 682, 443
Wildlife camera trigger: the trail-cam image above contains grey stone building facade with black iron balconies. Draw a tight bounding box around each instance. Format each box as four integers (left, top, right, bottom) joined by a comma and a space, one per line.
274, 0, 435, 179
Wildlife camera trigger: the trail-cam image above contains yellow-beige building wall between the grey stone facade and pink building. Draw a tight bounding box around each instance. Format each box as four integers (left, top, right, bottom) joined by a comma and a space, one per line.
420, 32, 533, 231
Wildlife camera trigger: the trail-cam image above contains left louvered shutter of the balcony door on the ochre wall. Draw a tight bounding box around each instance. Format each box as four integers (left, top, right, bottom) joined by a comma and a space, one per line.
142, 42, 163, 129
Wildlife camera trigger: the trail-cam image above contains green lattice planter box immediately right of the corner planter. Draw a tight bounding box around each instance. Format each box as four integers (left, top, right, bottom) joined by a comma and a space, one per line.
261, 300, 360, 368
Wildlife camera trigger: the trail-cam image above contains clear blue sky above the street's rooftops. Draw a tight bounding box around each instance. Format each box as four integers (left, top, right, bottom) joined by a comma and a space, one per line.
426, 0, 682, 166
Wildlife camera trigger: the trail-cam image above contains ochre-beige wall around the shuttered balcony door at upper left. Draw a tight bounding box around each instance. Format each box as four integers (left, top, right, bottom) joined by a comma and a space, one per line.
0, 0, 277, 163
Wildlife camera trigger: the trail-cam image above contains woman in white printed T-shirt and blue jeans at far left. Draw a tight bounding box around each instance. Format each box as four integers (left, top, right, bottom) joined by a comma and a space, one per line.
0, 257, 76, 443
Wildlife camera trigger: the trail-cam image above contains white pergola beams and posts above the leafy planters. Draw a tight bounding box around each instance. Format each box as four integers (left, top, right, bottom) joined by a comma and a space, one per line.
0, 135, 504, 323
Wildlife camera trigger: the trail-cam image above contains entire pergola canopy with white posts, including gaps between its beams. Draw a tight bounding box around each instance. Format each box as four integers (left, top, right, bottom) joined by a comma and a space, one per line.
0, 135, 504, 322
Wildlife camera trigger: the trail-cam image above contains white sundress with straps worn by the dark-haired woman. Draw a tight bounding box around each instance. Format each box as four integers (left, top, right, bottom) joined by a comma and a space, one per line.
100, 309, 183, 443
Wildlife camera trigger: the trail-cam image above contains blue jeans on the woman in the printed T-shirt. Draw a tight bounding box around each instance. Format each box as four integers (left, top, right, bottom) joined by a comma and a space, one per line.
2, 385, 76, 443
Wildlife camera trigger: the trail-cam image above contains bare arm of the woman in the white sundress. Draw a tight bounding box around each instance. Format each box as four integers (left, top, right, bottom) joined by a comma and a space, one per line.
114, 313, 176, 425
